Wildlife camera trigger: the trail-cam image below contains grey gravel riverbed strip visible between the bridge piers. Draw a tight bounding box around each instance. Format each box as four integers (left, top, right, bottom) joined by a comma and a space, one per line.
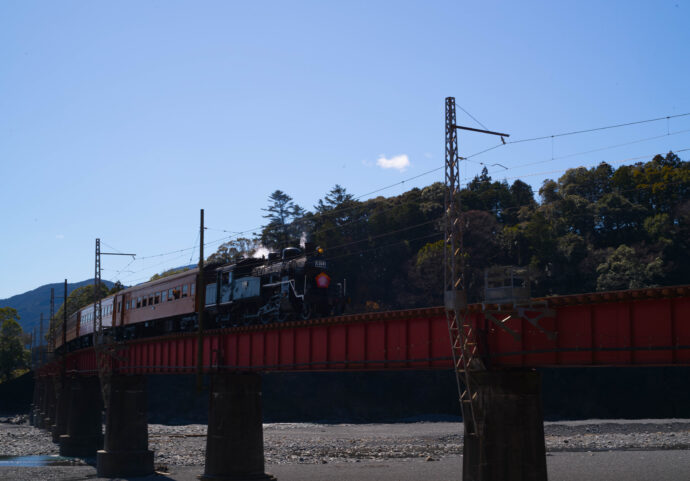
0, 419, 690, 466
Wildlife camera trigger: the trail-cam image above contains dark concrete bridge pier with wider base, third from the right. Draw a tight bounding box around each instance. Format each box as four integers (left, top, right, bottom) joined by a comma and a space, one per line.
96, 375, 153, 478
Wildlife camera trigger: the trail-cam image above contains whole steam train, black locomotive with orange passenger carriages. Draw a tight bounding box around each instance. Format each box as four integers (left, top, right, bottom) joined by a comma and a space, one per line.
55, 243, 347, 353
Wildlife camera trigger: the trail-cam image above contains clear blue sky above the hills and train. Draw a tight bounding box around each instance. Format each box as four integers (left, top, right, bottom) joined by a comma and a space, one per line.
0, 0, 690, 298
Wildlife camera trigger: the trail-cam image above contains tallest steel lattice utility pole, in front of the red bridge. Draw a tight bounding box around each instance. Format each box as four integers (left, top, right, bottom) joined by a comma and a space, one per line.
444, 97, 509, 472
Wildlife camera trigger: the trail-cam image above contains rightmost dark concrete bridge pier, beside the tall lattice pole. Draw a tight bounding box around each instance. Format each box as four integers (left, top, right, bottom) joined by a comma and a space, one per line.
463, 369, 546, 481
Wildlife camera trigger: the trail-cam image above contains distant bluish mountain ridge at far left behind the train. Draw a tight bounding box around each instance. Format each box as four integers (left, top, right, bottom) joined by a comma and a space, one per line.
0, 279, 113, 333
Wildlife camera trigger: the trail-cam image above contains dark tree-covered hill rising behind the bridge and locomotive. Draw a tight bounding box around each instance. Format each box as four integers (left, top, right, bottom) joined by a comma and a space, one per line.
235, 153, 690, 309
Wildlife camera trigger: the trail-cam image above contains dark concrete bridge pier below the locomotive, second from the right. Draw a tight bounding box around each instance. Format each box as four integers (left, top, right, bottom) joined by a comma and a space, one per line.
201, 373, 275, 481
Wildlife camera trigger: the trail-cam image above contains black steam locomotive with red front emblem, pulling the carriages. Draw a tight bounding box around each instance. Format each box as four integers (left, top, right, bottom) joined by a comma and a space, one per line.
206, 244, 345, 327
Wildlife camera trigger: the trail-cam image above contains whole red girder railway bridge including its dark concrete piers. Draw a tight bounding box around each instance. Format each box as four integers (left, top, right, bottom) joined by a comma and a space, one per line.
32, 286, 690, 481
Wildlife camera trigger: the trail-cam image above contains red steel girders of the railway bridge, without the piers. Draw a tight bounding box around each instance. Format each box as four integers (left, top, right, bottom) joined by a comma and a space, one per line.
39, 286, 690, 375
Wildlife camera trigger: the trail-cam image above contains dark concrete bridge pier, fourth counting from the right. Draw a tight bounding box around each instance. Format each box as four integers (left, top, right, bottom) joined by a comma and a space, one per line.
60, 376, 103, 457
